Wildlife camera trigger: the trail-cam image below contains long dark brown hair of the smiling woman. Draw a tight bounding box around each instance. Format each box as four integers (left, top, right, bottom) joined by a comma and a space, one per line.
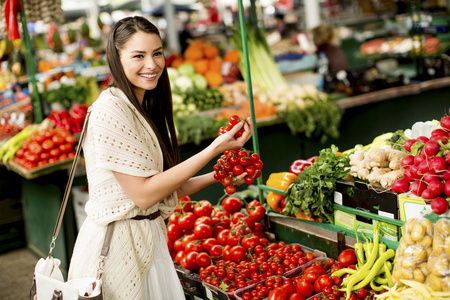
106, 16, 180, 170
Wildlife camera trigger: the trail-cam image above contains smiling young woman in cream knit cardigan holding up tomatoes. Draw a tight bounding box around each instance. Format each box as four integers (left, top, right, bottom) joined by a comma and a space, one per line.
69, 16, 252, 300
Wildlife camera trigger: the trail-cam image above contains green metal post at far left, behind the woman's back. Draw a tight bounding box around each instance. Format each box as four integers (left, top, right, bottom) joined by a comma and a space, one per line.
20, 0, 43, 123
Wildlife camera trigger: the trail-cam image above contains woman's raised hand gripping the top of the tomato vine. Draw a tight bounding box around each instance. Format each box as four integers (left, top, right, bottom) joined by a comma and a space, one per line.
210, 118, 253, 155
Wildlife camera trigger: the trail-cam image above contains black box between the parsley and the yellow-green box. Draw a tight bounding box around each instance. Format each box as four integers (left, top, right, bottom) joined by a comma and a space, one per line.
334, 181, 399, 219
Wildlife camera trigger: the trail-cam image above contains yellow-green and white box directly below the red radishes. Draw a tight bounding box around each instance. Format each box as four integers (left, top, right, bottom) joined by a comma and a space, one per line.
398, 192, 450, 223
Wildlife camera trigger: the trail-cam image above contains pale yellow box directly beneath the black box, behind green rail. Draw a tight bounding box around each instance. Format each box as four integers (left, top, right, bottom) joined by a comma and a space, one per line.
334, 210, 400, 242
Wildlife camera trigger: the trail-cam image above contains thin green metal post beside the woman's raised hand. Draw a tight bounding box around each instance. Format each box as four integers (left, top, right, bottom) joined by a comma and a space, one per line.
238, 0, 264, 203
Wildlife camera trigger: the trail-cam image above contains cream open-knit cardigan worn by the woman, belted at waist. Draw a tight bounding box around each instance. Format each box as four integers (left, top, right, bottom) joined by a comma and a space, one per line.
68, 88, 177, 300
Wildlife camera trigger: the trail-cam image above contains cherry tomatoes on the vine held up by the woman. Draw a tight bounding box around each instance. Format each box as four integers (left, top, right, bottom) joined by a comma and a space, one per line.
213, 115, 263, 195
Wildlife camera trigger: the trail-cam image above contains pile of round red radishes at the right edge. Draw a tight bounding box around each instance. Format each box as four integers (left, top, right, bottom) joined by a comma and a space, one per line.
391, 112, 450, 214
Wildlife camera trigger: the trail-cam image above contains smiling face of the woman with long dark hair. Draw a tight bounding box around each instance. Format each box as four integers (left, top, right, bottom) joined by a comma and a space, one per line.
120, 31, 166, 104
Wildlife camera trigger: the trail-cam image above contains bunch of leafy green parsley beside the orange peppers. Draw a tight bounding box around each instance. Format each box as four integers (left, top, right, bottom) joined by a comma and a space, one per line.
284, 145, 350, 224
